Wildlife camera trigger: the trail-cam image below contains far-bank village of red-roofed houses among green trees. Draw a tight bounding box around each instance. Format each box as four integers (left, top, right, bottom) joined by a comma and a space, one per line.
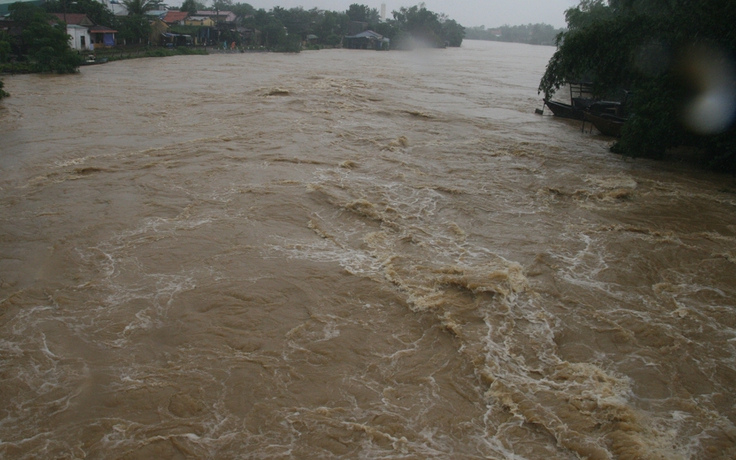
0, 0, 464, 64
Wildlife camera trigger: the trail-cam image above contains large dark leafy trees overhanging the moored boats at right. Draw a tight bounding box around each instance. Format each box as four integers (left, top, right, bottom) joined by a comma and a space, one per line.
539, 0, 736, 173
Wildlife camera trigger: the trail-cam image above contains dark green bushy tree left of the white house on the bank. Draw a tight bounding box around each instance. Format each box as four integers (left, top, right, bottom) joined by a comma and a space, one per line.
9, 2, 81, 73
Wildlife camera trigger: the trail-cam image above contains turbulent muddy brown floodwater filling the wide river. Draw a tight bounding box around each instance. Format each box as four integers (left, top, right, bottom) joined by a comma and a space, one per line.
0, 41, 736, 459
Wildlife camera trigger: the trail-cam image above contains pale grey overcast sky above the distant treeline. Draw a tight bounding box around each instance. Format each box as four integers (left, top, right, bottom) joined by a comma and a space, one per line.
177, 0, 579, 27
